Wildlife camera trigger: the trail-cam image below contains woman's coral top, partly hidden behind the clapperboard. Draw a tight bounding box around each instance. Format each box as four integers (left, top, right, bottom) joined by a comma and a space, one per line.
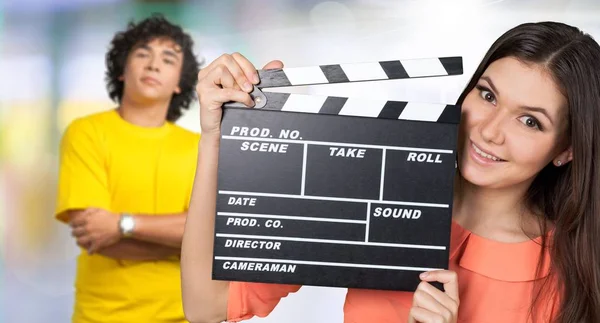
227, 222, 559, 323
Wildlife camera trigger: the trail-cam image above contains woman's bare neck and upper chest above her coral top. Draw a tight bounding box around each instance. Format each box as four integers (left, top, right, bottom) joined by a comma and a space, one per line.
453, 176, 540, 242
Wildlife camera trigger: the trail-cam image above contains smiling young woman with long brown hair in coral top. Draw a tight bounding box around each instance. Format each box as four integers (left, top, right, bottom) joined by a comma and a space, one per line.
182, 22, 600, 323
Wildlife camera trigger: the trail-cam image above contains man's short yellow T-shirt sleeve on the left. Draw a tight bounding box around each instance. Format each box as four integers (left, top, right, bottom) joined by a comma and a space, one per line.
55, 119, 111, 222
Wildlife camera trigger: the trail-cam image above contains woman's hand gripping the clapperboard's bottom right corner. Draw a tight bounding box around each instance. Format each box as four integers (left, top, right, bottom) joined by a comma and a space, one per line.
408, 270, 459, 323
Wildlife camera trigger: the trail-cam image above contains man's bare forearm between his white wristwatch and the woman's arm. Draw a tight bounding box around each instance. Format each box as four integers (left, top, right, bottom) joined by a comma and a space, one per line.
132, 213, 187, 248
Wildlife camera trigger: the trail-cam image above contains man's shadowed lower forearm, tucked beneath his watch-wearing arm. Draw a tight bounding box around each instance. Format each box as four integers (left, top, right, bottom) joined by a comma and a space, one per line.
98, 239, 180, 260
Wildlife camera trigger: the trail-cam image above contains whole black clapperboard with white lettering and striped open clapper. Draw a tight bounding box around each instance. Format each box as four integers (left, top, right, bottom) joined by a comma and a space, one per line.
213, 57, 463, 291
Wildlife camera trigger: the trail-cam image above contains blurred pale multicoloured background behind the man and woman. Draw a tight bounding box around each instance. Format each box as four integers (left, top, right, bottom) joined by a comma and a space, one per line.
0, 0, 600, 323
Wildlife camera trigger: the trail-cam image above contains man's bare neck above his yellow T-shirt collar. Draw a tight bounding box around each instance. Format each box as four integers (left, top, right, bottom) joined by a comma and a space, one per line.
118, 96, 169, 128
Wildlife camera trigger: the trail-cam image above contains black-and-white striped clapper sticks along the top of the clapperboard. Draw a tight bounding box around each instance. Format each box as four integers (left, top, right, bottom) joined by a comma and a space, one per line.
223, 56, 463, 124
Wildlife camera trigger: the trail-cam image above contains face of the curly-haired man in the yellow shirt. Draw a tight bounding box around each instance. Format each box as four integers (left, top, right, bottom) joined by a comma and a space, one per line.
121, 38, 183, 104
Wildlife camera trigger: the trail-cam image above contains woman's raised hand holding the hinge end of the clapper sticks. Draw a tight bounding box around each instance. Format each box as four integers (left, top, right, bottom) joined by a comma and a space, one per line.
196, 53, 283, 135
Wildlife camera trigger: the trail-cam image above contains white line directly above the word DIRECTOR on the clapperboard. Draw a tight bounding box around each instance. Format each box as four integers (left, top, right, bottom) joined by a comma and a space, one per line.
216, 233, 446, 250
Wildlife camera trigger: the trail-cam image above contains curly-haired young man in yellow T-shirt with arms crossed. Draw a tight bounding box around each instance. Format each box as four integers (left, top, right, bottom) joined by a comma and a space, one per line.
56, 16, 200, 323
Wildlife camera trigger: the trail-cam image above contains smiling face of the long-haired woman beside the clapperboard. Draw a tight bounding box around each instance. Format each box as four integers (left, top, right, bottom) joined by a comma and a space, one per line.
459, 57, 570, 188
